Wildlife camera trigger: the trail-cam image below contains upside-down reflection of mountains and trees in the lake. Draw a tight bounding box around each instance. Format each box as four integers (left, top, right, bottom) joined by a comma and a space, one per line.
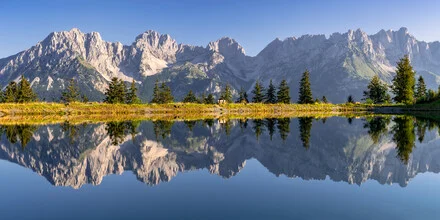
0, 116, 440, 188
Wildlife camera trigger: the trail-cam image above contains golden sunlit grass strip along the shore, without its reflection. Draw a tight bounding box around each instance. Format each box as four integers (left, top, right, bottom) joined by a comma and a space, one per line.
0, 102, 373, 116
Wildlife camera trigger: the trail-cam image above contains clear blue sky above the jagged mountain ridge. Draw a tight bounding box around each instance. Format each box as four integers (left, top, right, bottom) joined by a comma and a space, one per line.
0, 0, 440, 57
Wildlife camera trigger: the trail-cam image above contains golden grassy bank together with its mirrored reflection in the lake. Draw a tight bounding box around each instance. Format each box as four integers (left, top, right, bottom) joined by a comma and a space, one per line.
0, 102, 440, 124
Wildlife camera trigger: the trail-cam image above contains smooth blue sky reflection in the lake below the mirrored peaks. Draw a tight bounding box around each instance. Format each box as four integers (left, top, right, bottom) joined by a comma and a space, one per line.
0, 160, 440, 219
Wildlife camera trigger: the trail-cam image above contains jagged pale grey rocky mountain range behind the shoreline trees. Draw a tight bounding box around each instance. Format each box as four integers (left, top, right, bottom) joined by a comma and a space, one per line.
0, 28, 440, 102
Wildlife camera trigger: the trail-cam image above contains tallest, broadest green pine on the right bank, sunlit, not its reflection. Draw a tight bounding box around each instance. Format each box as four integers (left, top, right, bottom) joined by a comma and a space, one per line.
391, 55, 416, 105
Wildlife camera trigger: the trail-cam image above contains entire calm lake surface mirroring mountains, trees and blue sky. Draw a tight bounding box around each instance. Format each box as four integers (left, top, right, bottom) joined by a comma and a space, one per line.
0, 116, 440, 219
